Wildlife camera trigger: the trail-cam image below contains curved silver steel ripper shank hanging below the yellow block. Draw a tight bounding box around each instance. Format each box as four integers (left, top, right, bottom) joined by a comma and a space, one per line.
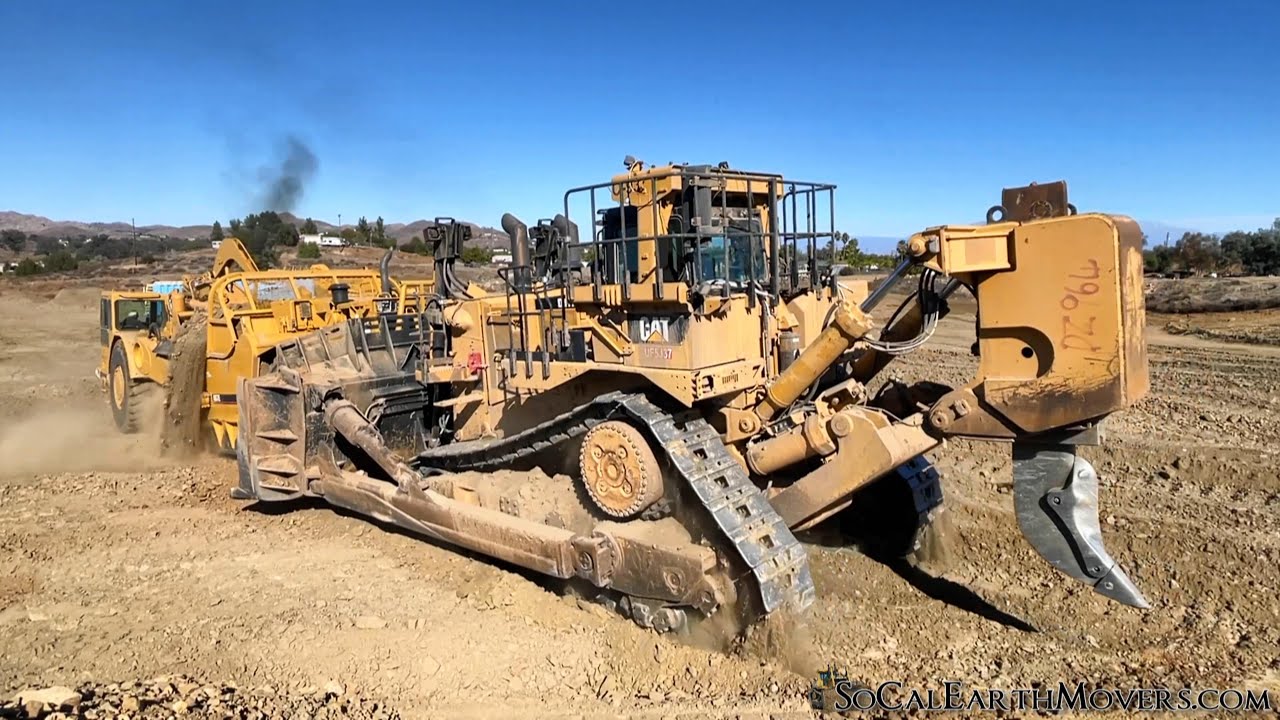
1014, 443, 1151, 609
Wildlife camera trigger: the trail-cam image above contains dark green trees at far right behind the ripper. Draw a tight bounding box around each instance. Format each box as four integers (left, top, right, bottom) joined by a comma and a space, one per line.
1143, 218, 1280, 275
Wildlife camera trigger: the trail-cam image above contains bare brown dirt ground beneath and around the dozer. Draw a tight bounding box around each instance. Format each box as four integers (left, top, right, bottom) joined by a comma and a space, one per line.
0, 283, 1280, 719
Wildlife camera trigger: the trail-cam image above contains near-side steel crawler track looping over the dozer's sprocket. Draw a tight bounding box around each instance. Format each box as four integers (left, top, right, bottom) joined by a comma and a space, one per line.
417, 392, 815, 615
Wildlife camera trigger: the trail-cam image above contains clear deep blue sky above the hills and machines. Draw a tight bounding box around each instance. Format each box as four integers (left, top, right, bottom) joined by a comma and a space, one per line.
0, 0, 1280, 249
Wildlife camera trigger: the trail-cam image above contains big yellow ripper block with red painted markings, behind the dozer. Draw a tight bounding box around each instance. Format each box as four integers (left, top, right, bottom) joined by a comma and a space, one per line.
974, 210, 1148, 432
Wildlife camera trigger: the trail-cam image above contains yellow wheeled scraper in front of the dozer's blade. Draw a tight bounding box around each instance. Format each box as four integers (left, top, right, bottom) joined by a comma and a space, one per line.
96, 238, 433, 452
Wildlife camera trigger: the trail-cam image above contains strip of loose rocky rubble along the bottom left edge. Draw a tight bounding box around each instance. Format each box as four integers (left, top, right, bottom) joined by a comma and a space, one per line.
0, 676, 401, 720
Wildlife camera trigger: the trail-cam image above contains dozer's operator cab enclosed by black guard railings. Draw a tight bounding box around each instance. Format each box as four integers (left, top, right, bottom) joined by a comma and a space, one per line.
566, 158, 836, 301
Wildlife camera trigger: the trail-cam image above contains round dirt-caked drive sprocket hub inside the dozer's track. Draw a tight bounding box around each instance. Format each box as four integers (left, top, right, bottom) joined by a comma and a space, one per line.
579, 420, 663, 519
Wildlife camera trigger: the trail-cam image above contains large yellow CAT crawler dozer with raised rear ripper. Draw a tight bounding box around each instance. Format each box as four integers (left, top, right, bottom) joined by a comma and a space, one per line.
233, 158, 1148, 630
